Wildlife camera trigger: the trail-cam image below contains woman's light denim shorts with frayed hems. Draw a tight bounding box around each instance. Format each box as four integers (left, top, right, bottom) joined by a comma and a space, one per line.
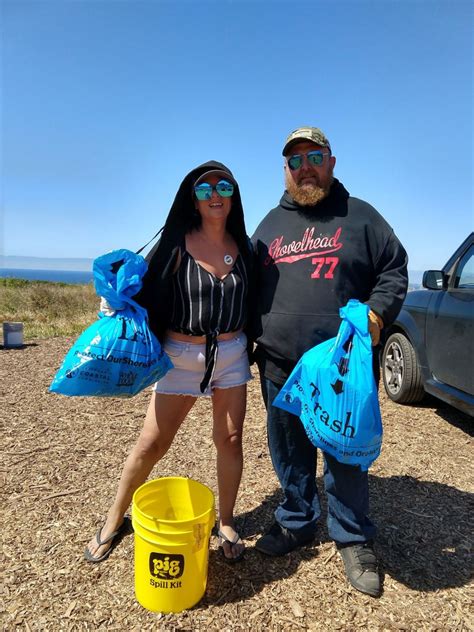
153, 333, 252, 397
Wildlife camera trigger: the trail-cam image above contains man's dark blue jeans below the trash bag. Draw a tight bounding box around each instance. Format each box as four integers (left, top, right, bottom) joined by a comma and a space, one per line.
260, 375, 375, 544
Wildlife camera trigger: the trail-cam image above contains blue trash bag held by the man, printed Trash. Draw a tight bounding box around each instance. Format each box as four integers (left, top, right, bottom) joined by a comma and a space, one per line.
273, 299, 382, 470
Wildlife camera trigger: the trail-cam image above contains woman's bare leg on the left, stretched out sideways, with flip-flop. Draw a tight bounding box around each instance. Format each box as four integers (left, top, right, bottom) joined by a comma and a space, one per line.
88, 393, 196, 557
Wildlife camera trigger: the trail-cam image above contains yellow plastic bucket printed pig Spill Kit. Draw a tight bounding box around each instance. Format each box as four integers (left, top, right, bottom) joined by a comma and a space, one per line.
132, 477, 216, 612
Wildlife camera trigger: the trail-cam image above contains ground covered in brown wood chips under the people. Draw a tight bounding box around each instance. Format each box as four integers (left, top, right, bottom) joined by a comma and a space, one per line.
0, 338, 473, 632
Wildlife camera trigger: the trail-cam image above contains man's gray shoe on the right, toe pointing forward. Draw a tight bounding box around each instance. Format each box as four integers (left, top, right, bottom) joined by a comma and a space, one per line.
337, 542, 382, 597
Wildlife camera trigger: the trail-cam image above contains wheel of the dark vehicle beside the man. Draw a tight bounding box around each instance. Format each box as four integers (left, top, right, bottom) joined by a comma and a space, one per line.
382, 333, 425, 404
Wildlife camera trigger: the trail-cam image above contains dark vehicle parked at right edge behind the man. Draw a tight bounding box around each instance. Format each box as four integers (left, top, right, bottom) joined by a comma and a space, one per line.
382, 232, 474, 417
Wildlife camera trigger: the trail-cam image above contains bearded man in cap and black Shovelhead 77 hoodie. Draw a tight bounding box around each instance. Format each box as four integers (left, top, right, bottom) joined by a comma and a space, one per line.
252, 127, 408, 596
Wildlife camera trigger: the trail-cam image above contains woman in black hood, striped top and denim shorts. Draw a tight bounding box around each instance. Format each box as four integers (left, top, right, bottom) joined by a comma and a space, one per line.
84, 162, 252, 562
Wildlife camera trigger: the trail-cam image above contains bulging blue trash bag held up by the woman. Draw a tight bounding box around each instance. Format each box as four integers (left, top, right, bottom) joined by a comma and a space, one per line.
49, 249, 173, 397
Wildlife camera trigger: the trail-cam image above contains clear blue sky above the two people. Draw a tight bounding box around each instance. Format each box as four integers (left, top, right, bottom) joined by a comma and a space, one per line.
0, 0, 474, 270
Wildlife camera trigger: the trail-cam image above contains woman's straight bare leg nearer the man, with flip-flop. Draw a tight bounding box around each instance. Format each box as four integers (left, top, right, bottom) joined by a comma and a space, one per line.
212, 384, 247, 557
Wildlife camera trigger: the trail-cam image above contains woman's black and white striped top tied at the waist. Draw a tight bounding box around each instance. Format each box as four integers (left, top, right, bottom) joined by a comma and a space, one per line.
169, 248, 248, 336
